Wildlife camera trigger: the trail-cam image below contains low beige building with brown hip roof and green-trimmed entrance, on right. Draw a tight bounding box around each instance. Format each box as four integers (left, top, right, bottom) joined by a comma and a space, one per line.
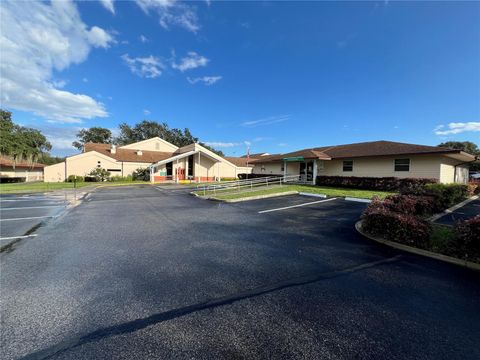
251, 141, 476, 183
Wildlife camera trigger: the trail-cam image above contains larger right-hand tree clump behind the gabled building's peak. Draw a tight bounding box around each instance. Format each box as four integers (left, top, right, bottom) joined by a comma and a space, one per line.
115, 120, 224, 156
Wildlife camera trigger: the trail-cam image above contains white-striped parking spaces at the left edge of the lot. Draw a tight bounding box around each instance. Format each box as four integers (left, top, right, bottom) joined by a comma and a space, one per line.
0, 194, 68, 246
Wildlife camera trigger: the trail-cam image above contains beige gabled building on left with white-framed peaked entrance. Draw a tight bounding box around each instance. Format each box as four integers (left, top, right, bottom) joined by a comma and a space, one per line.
44, 137, 253, 182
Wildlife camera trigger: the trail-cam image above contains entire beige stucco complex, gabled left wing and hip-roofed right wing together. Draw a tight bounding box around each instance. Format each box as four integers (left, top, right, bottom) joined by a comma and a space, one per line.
44, 137, 476, 183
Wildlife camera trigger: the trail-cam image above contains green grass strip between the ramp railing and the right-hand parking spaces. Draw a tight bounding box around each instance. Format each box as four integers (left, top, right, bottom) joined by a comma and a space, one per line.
201, 185, 393, 200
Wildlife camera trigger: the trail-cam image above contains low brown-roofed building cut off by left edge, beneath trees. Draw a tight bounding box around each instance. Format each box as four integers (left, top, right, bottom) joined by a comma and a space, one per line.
0, 156, 45, 182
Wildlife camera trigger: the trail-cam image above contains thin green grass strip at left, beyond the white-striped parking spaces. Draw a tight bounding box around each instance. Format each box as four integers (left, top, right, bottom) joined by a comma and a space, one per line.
0, 181, 149, 194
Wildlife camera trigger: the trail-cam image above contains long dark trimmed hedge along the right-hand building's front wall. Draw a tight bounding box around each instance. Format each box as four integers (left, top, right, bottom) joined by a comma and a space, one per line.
315, 176, 437, 192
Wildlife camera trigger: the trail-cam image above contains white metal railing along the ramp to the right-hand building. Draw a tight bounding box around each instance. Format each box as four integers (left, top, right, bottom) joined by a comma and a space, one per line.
197, 175, 301, 196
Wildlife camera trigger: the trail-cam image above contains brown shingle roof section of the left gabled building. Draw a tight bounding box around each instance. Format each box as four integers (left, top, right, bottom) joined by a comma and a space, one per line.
84, 143, 173, 163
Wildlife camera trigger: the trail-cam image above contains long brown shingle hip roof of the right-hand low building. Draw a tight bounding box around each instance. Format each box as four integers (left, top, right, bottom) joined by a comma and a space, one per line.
249, 140, 466, 163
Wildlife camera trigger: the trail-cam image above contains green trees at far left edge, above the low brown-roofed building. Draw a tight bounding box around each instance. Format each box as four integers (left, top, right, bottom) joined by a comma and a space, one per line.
0, 109, 52, 164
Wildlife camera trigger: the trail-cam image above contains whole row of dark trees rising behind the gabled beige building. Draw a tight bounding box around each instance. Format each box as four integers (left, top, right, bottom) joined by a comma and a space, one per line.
72, 120, 223, 156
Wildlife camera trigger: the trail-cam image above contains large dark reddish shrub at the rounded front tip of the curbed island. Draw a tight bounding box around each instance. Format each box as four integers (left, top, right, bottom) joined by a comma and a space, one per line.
362, 201, 430, 248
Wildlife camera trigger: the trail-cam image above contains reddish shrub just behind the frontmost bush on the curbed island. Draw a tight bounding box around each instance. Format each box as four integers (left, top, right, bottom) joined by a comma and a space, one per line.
384, 195, 437, 216
